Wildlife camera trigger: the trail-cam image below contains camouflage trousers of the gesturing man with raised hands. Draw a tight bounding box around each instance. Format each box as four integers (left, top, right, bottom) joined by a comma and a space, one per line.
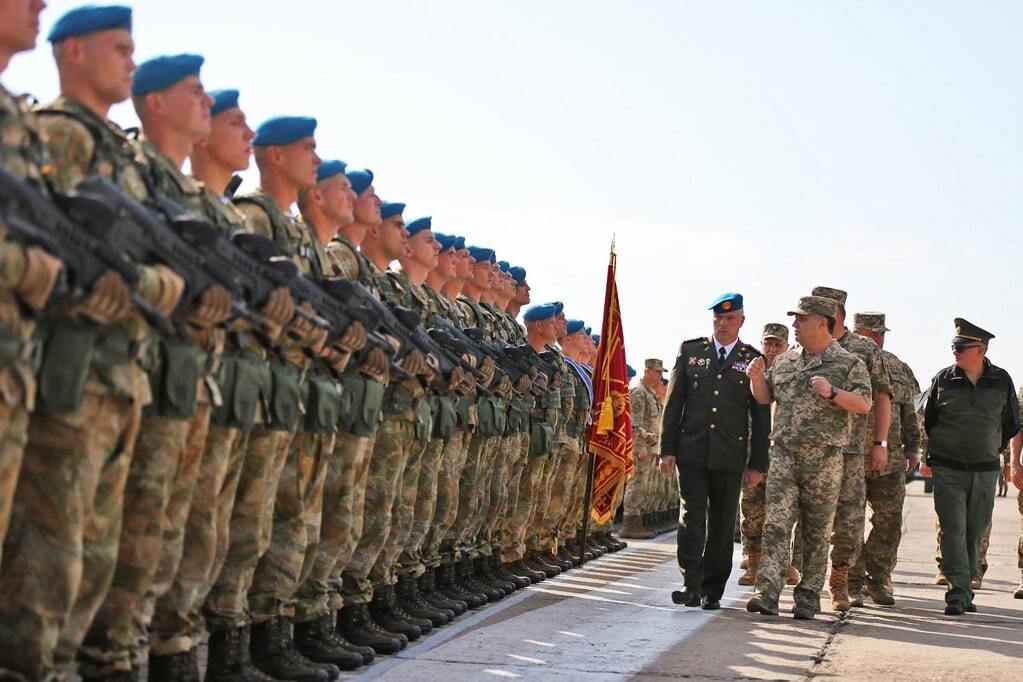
756, 444, 842, 608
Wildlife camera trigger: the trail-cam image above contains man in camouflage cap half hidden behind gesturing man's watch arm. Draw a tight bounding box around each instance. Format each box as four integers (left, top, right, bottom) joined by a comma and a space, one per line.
812, 286, 892, 610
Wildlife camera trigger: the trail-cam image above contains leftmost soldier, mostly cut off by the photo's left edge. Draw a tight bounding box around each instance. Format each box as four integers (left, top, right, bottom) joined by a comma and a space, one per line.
0, 2, 60, 557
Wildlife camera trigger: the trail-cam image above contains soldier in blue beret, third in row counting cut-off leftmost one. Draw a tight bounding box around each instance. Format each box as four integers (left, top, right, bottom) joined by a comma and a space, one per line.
79, 55, 230, 680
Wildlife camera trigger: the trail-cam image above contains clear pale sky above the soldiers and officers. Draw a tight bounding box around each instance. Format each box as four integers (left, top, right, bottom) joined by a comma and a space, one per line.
3, 0, 1023, 383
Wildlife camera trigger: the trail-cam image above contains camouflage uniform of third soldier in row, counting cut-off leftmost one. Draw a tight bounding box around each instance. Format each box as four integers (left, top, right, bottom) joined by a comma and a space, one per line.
79, 139, 223, 677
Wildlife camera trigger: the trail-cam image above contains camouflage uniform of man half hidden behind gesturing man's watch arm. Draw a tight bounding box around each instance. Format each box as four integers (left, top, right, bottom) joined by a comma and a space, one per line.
831, 330, 892, 569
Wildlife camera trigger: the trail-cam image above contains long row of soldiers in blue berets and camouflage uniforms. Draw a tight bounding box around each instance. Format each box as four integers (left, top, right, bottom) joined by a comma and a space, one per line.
0, 0, 624, 682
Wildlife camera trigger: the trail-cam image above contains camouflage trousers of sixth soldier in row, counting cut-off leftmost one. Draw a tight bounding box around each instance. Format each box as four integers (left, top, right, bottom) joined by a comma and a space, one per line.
249, 431, 335, 625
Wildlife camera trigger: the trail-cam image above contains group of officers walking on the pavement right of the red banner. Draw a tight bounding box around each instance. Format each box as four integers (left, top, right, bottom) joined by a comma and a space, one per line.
660, 286, 1023, 620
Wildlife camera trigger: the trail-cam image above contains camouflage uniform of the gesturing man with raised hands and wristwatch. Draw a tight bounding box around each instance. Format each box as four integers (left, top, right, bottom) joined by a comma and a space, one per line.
756, 342, 872, 609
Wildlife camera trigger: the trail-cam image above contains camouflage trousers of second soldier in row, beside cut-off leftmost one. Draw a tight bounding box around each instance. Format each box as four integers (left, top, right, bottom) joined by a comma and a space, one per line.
0, 381, 141, 679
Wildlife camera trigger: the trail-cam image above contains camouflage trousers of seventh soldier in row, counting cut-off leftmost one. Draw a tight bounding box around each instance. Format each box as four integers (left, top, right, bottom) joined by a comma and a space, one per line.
295, 431, 376, 623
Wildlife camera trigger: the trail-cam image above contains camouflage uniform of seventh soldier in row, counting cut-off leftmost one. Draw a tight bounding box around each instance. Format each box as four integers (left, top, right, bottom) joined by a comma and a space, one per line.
295, 236, 384, 623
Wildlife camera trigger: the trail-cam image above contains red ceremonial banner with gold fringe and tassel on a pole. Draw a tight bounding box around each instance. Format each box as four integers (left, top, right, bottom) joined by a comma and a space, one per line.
588, 245, 635, 524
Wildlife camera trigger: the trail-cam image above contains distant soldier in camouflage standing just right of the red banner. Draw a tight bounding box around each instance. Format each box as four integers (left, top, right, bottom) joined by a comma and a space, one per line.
622, 358, 665, 540
